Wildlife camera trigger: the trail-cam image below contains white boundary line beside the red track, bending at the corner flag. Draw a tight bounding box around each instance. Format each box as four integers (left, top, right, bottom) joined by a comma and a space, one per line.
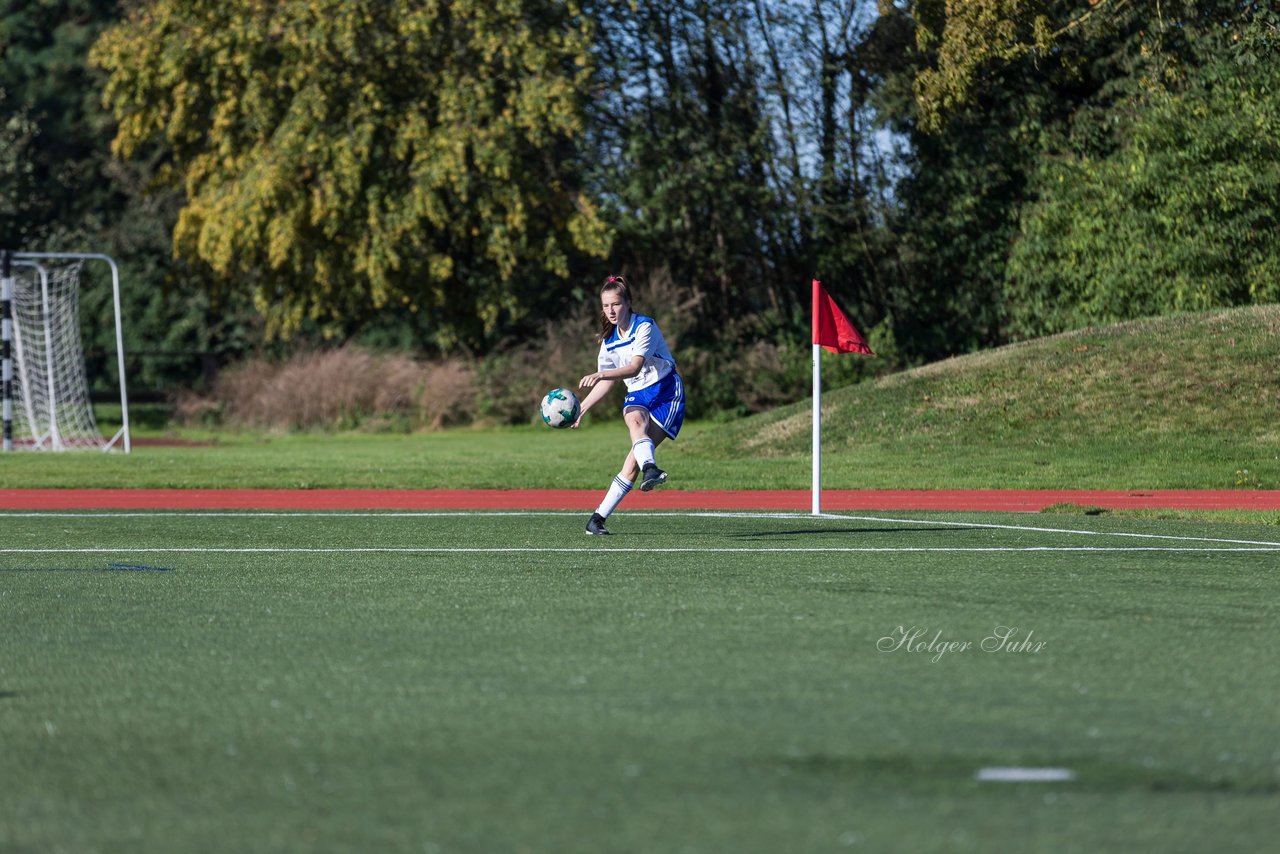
0, 510, 1280, 553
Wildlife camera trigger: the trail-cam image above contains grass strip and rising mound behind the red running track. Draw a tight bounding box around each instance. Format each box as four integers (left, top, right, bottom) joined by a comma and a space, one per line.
10, 306, 1280, 489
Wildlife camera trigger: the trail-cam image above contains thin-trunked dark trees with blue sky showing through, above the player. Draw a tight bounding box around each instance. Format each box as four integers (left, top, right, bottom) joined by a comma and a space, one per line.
590, 0, 888, 337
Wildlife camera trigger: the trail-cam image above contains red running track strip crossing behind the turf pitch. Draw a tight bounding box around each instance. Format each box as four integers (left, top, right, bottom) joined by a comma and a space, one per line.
0, 489, 1280, 512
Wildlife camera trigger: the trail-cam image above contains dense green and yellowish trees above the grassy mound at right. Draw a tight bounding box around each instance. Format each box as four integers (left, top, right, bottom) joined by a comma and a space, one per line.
865, 0, 1275, 356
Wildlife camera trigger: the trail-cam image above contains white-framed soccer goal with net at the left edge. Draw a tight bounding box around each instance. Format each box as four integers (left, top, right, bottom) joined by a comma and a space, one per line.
0, 251, 132, 453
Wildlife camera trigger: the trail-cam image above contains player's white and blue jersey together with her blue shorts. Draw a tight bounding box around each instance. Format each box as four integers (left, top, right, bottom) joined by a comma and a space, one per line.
596, 314, 685, 439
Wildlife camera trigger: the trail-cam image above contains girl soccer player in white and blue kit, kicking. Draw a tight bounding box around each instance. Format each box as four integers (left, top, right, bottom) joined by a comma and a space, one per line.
573, 275, 685, 534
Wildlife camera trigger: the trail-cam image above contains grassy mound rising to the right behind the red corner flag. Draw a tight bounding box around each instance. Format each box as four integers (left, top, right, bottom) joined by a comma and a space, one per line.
687, 305, 1280, 489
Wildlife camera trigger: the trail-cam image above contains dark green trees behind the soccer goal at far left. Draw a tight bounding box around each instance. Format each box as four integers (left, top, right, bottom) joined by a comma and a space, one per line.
0, 0, 248, 393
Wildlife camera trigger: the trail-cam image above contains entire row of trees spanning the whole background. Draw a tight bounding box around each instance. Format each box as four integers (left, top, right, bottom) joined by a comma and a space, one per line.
0, 0, 1280, 411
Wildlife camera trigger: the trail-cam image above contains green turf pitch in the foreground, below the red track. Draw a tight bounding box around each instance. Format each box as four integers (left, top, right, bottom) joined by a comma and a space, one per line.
0, 512, 1280, 853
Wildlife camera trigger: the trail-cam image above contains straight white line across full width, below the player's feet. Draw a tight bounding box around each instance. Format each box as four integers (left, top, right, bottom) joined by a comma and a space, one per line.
0, 544, 1280, 554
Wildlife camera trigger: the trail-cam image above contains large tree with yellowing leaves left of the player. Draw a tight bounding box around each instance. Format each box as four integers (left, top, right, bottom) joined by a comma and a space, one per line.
92, 0, 609, 347
